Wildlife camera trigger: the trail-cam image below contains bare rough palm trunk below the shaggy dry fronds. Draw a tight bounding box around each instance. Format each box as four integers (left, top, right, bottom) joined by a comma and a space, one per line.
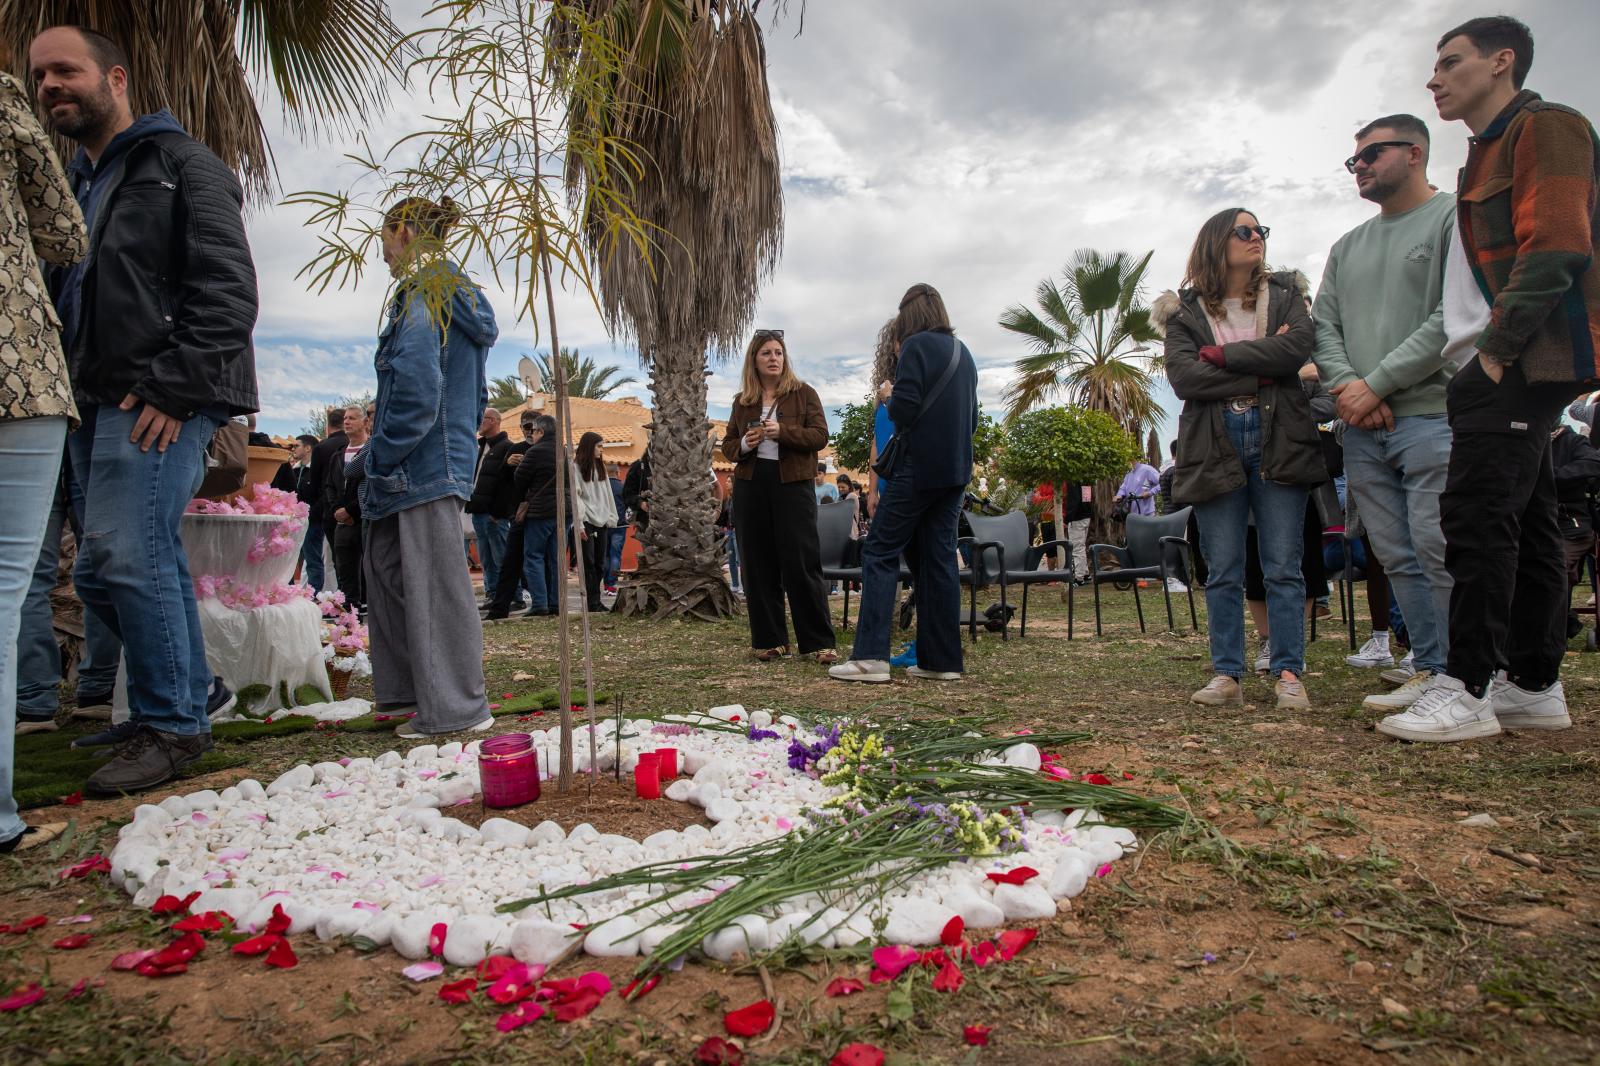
618, 329, 739, 621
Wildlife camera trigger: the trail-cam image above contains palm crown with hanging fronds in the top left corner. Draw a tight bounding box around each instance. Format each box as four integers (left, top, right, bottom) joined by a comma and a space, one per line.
0, 0, 402, 205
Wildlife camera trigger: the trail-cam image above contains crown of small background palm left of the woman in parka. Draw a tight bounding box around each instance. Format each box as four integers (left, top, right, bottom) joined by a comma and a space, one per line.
1000, 248, 1162, 435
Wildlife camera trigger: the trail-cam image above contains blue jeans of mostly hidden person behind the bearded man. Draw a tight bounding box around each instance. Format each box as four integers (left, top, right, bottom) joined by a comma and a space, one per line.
16, 464, 122, 717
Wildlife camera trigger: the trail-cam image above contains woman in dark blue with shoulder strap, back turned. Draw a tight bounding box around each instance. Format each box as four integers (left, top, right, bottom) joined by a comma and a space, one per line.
829, 283, 978, 683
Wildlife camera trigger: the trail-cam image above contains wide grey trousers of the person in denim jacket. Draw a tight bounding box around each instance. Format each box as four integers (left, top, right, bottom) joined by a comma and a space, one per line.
362, 496, 488, 733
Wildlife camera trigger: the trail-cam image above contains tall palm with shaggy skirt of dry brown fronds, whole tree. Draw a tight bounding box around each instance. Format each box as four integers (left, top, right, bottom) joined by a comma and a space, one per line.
568, 0, 784, 618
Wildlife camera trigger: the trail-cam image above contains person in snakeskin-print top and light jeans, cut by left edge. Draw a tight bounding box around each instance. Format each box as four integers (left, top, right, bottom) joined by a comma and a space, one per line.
0, 33, 88, 852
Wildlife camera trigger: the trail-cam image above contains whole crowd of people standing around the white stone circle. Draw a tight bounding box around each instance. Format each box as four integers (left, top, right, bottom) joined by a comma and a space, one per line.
0, 16, 1600, 850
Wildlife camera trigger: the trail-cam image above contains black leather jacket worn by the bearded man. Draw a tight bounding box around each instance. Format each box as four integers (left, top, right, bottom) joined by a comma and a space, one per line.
50, 117, 259, 421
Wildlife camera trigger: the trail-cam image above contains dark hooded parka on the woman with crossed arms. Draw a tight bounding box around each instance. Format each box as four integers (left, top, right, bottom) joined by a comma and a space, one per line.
1150, 271, 1328, 506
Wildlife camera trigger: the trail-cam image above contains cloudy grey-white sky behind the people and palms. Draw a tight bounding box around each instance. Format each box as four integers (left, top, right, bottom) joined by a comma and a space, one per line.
250, 0, 1600, 440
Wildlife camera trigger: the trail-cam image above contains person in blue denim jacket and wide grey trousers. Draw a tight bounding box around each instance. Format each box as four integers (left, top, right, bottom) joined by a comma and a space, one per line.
360, 197, 499, 739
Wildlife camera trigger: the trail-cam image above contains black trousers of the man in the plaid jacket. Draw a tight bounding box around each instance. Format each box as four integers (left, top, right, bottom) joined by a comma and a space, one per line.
1438, 359, 1579, 696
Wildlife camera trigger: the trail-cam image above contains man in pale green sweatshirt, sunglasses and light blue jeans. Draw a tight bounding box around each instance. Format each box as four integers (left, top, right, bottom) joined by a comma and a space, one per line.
1314, 115, 1454, 711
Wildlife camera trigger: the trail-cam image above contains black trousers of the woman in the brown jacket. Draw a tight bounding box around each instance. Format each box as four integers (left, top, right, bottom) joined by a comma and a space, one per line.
733, 459, 835, 655
